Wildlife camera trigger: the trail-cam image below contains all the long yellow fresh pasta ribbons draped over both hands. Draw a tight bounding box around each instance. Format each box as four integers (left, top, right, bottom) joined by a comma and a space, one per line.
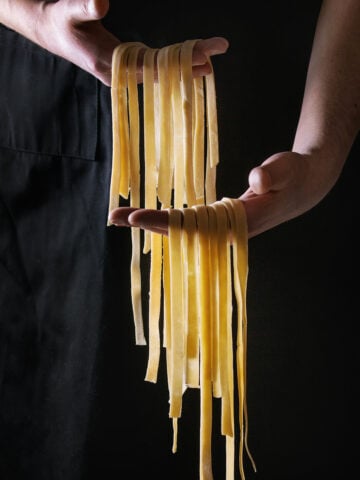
109, 40, 256, 480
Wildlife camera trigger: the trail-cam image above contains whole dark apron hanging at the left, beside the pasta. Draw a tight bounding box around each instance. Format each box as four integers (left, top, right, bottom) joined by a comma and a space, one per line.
0, 26, 111, 480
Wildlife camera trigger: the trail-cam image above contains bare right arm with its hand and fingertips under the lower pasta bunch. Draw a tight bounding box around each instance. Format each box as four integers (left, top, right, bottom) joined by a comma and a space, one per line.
109, 0, 360, 238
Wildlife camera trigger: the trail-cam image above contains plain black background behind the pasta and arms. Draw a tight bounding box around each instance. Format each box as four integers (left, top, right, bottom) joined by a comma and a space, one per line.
86, 0, 359, 480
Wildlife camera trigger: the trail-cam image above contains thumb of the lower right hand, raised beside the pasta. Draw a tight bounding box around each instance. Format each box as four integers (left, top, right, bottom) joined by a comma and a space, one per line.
248, 152, 301, 195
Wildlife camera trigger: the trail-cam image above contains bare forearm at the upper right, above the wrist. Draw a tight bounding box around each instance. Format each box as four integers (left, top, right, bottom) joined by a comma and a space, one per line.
293, 0, 360, 179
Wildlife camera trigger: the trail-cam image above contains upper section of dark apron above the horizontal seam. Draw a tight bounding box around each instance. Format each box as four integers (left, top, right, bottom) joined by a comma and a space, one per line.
0, 25, 98, 160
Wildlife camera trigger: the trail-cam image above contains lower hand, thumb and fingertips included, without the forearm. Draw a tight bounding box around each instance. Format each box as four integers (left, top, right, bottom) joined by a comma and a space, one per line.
109, 152, 340, 238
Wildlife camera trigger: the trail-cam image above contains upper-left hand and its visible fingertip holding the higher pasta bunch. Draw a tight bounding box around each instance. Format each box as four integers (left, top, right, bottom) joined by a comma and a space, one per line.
0, 0, 228, 86
